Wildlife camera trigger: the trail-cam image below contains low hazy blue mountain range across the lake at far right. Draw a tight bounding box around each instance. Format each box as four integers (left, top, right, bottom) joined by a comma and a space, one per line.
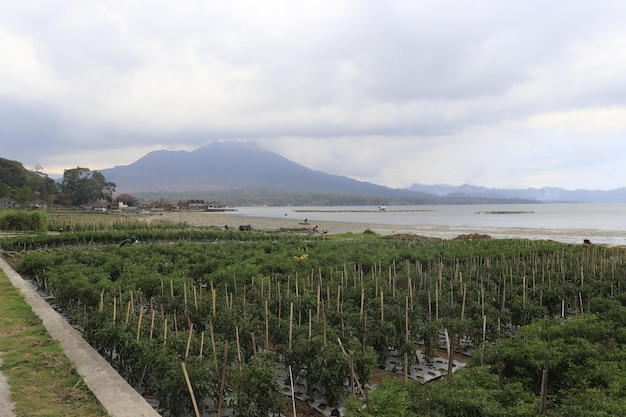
407, 184, 626, 203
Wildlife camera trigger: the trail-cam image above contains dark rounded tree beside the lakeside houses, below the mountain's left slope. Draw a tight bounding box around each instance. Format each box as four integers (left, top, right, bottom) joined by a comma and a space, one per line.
61, 167, 116, 206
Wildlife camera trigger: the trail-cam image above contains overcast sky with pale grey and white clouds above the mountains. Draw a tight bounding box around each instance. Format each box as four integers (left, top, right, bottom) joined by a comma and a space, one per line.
0, 0, 626, 189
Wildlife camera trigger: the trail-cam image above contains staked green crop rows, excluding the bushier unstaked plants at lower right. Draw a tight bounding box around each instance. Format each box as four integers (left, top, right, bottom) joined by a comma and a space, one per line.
9, 232, 626, 415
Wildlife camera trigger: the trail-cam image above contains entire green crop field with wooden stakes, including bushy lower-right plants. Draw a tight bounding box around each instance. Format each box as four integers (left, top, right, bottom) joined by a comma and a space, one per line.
1, 211, 626, 416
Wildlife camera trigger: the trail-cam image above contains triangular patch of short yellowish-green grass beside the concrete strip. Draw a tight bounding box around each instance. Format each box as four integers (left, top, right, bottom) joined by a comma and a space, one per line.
0, 271, 108, 417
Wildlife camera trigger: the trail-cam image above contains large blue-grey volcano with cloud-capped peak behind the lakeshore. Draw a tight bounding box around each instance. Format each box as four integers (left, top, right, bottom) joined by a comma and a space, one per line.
100, 142, 438, 204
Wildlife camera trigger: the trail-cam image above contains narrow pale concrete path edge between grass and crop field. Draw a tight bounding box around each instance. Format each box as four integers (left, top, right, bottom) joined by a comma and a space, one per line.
0, 257, 160, 417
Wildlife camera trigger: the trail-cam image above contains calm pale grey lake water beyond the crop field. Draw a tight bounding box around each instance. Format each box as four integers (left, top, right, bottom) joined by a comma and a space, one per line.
229, 204, 626, 245
